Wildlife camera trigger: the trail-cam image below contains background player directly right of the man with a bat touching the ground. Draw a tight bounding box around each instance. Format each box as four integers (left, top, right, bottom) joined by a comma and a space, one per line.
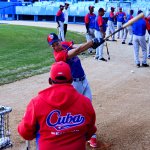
107, 7, 116, 41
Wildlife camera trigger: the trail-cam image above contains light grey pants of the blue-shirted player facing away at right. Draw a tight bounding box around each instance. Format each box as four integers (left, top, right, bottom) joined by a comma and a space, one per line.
133, 35, 147, 64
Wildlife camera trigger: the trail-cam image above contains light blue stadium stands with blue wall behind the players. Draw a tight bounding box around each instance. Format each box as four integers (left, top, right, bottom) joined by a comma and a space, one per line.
0, 1, 150, 23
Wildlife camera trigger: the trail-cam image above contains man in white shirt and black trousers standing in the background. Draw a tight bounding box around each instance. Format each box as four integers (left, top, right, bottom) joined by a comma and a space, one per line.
63, 3, 69, 37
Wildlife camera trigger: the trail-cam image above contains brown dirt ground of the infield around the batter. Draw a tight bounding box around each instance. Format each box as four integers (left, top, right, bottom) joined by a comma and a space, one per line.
0, 21, 150, 150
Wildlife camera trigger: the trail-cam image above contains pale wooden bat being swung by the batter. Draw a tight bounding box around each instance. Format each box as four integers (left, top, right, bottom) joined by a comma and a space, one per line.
104, 13, 144, 41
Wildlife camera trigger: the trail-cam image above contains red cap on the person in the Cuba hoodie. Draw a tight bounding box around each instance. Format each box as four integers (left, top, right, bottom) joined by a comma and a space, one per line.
50, 61, 72, 83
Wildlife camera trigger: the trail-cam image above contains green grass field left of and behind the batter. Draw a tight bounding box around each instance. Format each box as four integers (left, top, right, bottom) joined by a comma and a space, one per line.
0, 24, 85, 85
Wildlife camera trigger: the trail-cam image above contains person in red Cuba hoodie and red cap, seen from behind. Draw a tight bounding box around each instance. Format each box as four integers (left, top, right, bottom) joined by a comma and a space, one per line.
18, 61, 96, 150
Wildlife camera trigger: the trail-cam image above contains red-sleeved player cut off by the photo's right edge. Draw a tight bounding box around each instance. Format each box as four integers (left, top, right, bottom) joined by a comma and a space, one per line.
145, 13, 150, 59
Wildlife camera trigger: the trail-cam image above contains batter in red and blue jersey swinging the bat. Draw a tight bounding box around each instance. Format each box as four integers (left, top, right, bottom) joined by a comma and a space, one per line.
47, 33, 104, 147
